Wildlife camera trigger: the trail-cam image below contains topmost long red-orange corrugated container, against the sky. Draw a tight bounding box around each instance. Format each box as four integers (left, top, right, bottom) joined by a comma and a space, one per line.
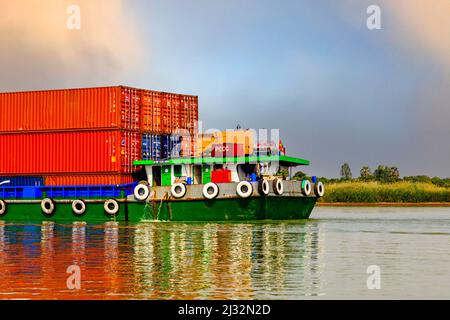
0, 86, 140, 132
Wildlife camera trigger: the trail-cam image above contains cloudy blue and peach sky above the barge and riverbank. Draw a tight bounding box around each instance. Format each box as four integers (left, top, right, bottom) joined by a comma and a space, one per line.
0, 0, 450, 177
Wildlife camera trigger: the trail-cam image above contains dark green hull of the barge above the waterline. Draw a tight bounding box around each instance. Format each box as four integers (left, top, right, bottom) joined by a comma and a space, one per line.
0, 196, 316, 222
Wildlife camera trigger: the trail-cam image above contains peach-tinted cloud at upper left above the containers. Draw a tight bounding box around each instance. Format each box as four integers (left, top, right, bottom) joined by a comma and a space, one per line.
0, 0, 143, 90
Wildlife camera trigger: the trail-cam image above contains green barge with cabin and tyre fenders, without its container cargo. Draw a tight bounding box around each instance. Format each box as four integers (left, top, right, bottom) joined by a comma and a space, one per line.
0, 155, 325, 222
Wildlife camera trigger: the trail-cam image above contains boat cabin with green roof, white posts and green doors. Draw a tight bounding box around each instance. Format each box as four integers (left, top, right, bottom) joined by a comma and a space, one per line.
134, 156, 310, 187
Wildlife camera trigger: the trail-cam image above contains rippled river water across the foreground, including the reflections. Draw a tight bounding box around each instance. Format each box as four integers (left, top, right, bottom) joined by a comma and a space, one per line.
0, 208, 450, 299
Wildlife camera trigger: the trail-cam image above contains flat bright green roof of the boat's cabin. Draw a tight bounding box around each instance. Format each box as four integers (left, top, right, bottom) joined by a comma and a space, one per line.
134, 156, 310, 167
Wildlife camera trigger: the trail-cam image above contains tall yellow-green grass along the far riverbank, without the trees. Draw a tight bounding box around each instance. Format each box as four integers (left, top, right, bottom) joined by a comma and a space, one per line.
320, 182, 450, 203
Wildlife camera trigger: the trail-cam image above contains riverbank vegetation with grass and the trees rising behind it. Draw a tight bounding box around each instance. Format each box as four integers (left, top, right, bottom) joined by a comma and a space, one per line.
294, 163, 450, 203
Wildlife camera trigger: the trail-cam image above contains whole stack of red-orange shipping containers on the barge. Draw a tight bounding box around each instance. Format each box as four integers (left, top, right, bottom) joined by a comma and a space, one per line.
0, 86, 198, 186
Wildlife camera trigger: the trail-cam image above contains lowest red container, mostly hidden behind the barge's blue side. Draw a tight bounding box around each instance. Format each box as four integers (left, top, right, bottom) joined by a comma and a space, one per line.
44, 174, 134, 186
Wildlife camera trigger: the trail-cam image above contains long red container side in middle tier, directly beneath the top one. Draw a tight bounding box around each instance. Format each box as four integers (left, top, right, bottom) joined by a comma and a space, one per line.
0, 130, 141, 175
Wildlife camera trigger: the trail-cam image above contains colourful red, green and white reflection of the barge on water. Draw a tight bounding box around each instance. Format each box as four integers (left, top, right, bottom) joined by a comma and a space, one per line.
0, 222, 322, 299
